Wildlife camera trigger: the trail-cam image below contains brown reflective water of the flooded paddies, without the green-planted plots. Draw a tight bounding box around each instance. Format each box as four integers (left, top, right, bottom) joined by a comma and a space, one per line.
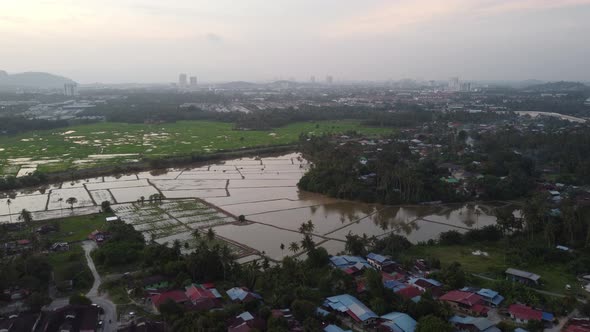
0, 154, 520, 256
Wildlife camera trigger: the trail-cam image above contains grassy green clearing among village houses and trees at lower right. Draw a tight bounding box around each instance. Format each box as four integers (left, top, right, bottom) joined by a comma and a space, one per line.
404, 243, 581, 294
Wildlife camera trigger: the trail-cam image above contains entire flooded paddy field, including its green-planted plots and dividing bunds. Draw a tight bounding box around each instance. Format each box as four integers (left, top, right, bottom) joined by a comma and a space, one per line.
0, 153, 520, 261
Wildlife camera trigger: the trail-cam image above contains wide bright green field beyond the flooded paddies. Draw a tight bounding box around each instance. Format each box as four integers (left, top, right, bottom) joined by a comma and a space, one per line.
0, 120, 392, 175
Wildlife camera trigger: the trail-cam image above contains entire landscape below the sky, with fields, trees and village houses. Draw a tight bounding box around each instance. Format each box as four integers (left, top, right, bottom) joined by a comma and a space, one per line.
0, 73, 590, 332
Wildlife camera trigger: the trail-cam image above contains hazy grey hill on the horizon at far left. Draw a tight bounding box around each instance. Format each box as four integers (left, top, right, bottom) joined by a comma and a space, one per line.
0, 70, 75, 90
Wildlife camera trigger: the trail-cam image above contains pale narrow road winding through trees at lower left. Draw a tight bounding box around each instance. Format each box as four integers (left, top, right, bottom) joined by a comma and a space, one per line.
82, 241, 117, 332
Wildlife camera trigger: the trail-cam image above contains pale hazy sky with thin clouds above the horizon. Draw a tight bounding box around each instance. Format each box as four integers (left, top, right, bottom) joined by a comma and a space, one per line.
0, 0, 590, 83
